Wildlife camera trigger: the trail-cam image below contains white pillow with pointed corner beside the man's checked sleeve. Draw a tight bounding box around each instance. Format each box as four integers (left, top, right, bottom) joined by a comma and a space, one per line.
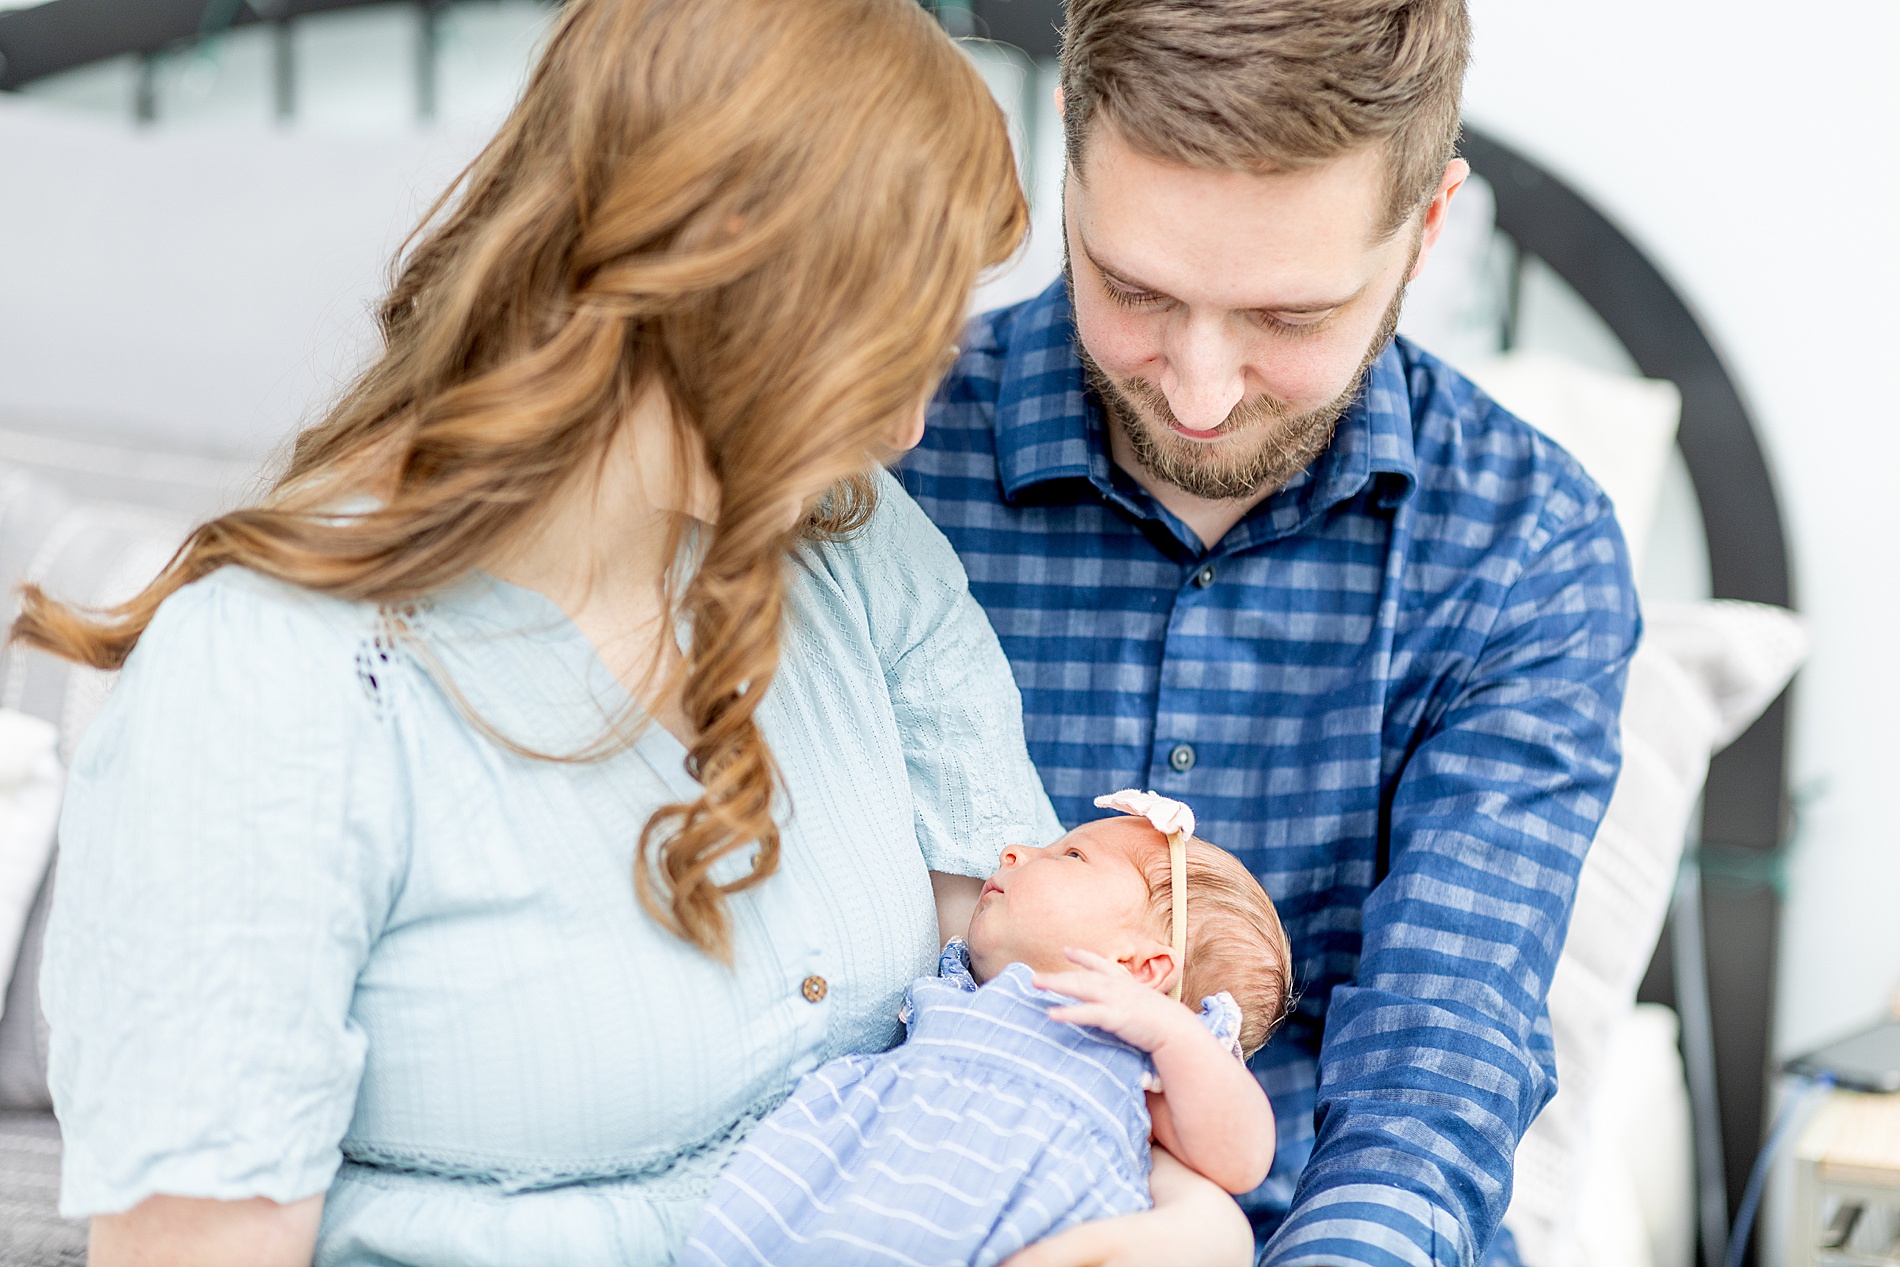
1505, 602, 1807, 1267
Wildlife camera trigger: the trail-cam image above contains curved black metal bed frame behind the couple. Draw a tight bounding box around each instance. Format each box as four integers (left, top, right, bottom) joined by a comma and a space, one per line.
0, 0, 1794, 1261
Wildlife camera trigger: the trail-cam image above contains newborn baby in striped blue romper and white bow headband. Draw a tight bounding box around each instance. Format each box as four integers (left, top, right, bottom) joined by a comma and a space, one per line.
678, 792, 1290, 1267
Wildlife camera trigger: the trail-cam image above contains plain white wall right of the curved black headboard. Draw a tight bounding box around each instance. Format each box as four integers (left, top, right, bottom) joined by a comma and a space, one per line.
1467, 0, 1900, 1054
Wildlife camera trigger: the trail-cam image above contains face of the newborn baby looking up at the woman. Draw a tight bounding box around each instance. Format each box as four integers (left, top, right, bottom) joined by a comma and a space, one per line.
967, 817, 1159, 980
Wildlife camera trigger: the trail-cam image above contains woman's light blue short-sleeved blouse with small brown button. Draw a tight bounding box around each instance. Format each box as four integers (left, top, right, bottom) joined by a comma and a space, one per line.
42, 479, 1060, 1267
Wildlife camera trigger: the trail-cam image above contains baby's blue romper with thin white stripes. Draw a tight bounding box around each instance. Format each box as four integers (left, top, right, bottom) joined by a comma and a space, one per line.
678, 940, 1241, 1267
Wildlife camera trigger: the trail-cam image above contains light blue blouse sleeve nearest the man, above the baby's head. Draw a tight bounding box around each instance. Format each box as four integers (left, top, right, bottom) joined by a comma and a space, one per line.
836, 473, 1062, 876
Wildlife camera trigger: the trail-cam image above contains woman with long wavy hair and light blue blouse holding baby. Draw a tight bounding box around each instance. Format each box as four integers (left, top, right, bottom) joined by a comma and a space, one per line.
13, 0, 1246, 1267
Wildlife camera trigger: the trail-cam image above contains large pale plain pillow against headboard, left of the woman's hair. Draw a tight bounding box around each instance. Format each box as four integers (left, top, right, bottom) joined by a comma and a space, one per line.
0, 101, 497, 456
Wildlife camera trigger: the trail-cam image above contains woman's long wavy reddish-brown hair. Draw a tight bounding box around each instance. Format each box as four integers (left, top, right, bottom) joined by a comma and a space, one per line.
11, 0, 1028, 957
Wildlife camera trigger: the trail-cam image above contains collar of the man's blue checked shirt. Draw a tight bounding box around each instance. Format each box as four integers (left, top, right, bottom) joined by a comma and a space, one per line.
996, 277, 1417, 539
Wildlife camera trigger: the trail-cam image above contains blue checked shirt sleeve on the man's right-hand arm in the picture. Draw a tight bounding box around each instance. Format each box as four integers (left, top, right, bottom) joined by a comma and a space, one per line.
1260, 480, 1640, 1267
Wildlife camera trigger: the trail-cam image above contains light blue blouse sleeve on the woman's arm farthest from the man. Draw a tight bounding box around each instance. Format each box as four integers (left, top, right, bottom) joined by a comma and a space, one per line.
42, 568, 401, 1218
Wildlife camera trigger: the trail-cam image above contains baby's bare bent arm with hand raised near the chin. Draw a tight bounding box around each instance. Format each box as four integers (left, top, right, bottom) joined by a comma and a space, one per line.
1036, 950, 1273, 1193
